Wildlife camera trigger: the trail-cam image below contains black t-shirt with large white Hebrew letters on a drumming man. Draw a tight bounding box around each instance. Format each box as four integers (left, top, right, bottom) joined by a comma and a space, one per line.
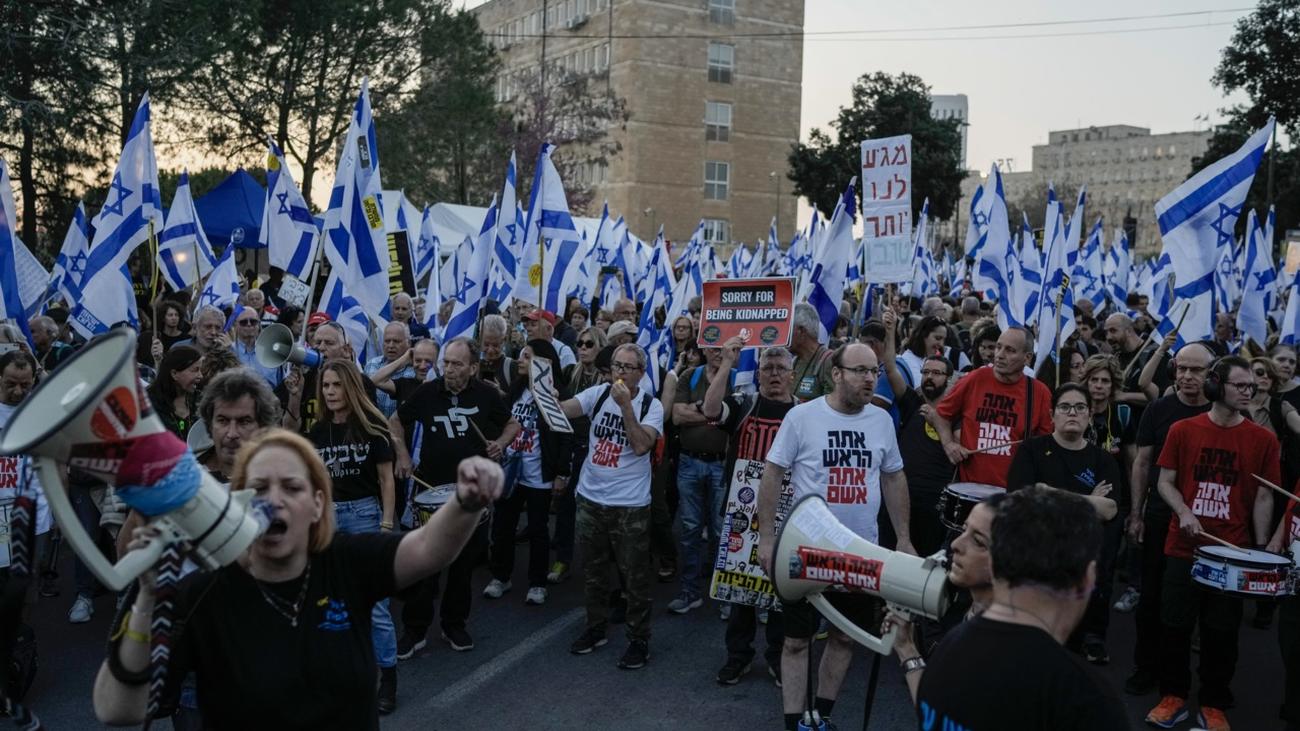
398, 379, 510, 485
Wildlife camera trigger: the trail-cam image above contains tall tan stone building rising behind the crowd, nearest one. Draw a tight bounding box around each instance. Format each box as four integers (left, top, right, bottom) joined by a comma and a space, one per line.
472, 0, 803, 248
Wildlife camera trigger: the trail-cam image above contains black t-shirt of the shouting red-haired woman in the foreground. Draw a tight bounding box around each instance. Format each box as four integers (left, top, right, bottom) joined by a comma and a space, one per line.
168, 533, 402, 730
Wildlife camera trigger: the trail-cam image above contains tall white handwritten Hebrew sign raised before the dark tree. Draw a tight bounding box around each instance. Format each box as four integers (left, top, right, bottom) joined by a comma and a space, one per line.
862, 134, 913, 284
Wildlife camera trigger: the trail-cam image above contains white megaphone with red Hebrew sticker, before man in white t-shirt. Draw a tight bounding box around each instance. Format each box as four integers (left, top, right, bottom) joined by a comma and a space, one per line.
772, 496, 949, 654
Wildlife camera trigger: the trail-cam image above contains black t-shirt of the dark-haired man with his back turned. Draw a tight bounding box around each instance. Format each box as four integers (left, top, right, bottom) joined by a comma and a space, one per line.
917, 613, 1130, 731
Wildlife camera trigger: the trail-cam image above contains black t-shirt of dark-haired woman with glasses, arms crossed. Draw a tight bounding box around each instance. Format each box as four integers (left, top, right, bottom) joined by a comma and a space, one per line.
1006, 434, 1119, 499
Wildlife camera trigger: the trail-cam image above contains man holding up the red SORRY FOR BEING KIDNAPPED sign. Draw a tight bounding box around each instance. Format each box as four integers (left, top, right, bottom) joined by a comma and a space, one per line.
702, 337, 794, 687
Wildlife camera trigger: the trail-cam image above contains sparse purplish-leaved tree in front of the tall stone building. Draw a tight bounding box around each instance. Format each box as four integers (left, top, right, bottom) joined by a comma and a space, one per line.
501, 68, 628, 215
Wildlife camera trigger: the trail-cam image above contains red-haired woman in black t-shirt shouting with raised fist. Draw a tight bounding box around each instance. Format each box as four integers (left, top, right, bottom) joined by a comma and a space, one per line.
94, 429, 503, 728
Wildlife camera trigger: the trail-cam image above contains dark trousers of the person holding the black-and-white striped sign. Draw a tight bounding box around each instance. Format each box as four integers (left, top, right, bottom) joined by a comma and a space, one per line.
489, 457, 551, 587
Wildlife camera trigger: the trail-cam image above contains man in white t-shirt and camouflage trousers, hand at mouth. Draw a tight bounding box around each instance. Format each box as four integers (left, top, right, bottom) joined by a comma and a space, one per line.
560, 345, 663, 670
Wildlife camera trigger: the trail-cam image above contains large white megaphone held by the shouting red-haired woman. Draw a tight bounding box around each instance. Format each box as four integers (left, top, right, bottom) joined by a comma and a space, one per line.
0, 329, 268, 591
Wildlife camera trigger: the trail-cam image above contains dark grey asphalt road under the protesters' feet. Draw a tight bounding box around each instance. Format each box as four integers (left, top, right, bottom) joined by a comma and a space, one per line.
15, 538, 1283, 731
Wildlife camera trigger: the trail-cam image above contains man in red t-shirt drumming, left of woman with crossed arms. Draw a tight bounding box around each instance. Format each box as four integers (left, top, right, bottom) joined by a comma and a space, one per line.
930, 328, 1052, 488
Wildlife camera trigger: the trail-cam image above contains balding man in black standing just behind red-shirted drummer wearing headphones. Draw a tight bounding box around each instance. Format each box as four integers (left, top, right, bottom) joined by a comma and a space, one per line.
1128, 338, 1214, 696
